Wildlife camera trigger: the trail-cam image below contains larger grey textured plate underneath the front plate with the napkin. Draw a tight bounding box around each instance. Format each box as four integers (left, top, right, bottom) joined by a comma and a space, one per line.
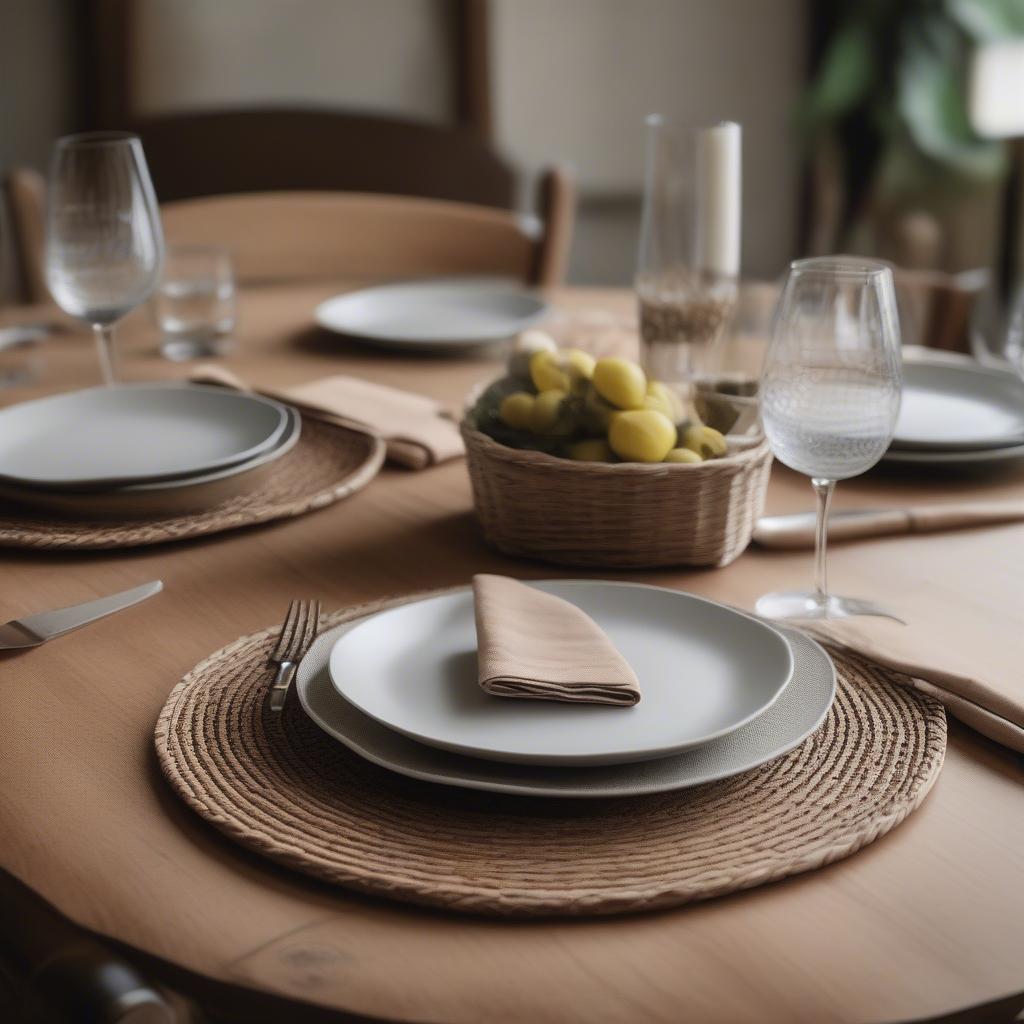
295, 623, 836, 798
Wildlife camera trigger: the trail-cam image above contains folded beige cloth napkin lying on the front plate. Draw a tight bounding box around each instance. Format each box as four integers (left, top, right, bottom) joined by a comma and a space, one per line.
473, 574, 640, 706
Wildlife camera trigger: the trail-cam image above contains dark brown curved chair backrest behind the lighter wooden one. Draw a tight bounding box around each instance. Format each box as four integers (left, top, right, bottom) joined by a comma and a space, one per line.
123, 108, 515, 209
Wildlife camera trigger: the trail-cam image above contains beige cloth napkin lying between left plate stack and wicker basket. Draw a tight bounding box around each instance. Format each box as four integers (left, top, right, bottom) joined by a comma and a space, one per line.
189, 364, 465, 469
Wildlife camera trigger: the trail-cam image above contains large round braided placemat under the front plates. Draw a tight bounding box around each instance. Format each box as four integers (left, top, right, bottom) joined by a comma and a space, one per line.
156, 595, 946, 915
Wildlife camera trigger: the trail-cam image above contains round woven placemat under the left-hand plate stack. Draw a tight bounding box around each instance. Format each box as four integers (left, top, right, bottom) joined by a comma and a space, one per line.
0, 417, 385, 550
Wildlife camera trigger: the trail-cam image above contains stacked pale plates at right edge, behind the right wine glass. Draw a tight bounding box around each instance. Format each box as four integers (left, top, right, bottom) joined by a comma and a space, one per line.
884, 361, 1024, 466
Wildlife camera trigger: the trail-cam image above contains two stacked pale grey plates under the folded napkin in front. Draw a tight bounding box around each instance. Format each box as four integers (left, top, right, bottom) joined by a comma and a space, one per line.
296, 581, 836, 797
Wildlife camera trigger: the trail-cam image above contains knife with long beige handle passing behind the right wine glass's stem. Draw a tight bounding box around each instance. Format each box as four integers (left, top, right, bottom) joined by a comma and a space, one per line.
754, 502, 1024, 548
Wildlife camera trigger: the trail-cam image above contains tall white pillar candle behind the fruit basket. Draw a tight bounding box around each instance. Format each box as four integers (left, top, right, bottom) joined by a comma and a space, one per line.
694, 121, 742, 278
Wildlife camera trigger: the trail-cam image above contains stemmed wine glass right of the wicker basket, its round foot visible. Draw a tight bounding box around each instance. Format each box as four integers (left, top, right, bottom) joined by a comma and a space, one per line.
757, 256, 902, 618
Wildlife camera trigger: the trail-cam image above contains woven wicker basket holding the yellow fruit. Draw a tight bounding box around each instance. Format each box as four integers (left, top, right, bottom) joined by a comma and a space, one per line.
462, 413, 771, 568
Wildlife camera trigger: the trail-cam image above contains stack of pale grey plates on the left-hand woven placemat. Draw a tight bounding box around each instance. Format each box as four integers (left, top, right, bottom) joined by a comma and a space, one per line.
0, 384, 301, 516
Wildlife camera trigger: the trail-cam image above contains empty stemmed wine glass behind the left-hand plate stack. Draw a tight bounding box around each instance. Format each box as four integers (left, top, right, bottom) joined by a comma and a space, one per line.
46, 132, 164, 384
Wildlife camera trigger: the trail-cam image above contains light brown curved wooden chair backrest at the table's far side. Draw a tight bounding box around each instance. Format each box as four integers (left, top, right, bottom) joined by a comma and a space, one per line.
161, 184, 564, 285
